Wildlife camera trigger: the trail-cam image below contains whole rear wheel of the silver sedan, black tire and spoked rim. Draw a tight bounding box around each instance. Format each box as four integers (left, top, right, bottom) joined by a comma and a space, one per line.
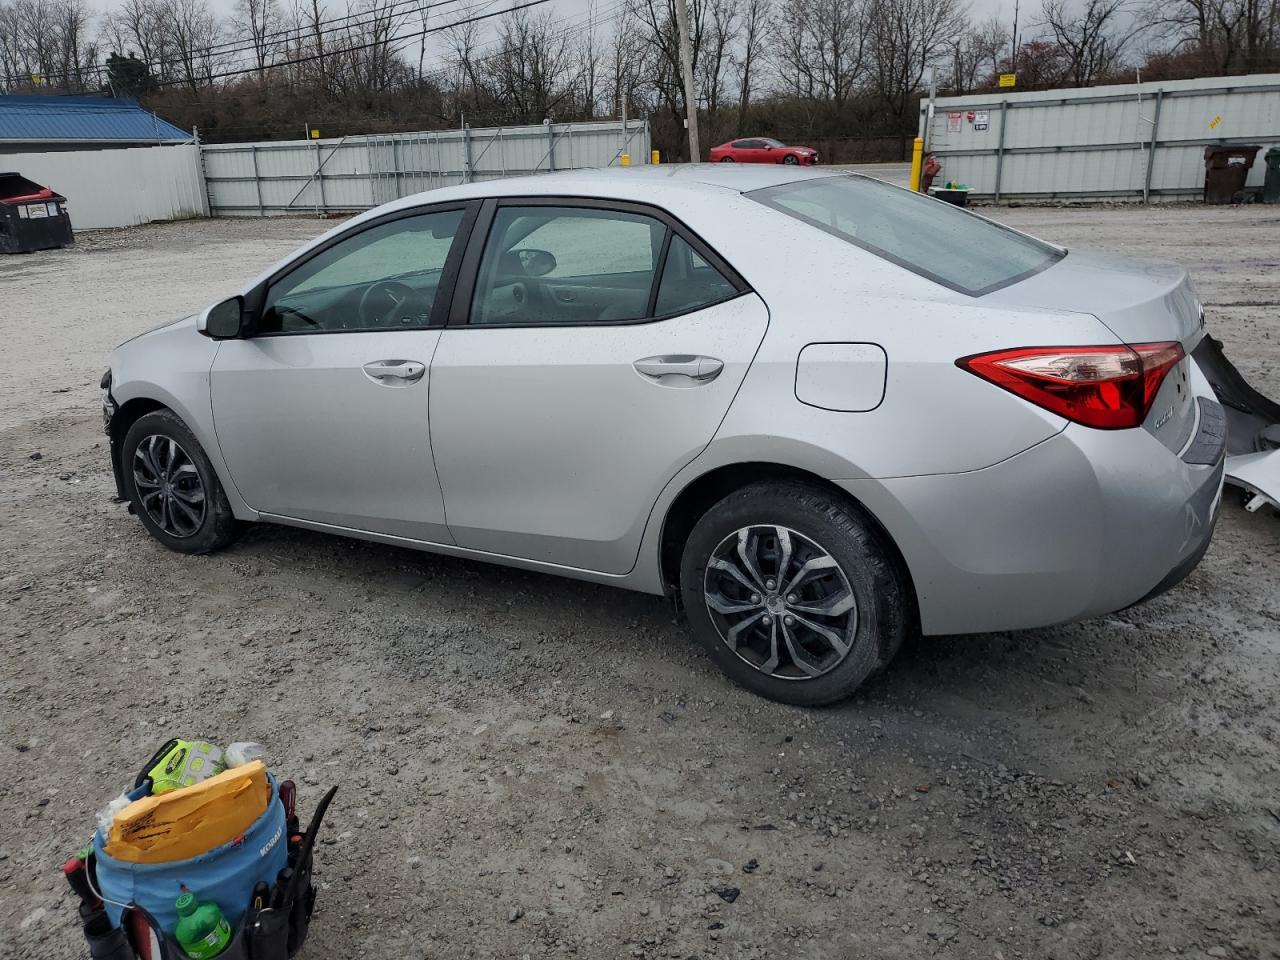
680, 483, 911, 707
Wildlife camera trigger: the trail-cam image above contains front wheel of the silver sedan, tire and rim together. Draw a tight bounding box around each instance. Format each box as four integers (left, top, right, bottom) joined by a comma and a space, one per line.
120, 410, 239, 553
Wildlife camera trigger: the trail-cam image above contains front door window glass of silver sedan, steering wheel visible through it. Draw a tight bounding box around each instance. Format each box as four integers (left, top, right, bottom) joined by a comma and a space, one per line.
259, 210, 462, 333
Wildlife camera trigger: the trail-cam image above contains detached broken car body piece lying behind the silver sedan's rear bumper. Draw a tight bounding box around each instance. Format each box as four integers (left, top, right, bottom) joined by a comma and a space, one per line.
1192, 337, 1280, 512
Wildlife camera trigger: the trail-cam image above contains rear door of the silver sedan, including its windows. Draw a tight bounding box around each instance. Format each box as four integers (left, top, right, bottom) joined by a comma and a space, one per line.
431, 200, 768, 573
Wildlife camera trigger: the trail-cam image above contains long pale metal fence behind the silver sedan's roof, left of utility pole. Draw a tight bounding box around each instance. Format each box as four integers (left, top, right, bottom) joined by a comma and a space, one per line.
202, 120, 650, 216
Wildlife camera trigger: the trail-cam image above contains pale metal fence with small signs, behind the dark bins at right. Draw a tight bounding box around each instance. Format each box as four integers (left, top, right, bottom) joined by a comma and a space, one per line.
920, 74, 1280, 200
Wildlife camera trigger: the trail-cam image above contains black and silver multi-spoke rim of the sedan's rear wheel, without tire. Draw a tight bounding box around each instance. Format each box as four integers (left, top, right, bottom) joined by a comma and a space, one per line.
703, 525, 858, 680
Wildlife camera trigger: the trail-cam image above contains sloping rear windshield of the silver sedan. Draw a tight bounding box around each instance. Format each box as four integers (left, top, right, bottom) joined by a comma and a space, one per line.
748, 175, 1065, 297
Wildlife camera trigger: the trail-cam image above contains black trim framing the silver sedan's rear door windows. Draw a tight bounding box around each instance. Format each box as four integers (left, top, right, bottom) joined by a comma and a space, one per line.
448, 195, 753, 330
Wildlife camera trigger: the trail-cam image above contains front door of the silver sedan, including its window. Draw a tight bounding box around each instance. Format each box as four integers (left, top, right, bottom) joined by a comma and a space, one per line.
210, 206, 475, 543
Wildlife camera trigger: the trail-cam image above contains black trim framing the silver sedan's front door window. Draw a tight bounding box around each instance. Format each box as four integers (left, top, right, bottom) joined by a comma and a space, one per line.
241, 200, 480, 339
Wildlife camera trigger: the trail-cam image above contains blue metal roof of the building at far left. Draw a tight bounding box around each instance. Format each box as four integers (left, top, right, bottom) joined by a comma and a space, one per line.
0, 96, 191, 154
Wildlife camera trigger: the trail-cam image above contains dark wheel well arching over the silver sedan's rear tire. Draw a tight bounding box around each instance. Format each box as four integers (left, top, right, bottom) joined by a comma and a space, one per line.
659, 463, 919, 627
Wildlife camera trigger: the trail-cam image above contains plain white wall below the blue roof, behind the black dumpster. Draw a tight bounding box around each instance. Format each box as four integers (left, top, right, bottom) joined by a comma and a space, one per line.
0, 143, 209, 230
